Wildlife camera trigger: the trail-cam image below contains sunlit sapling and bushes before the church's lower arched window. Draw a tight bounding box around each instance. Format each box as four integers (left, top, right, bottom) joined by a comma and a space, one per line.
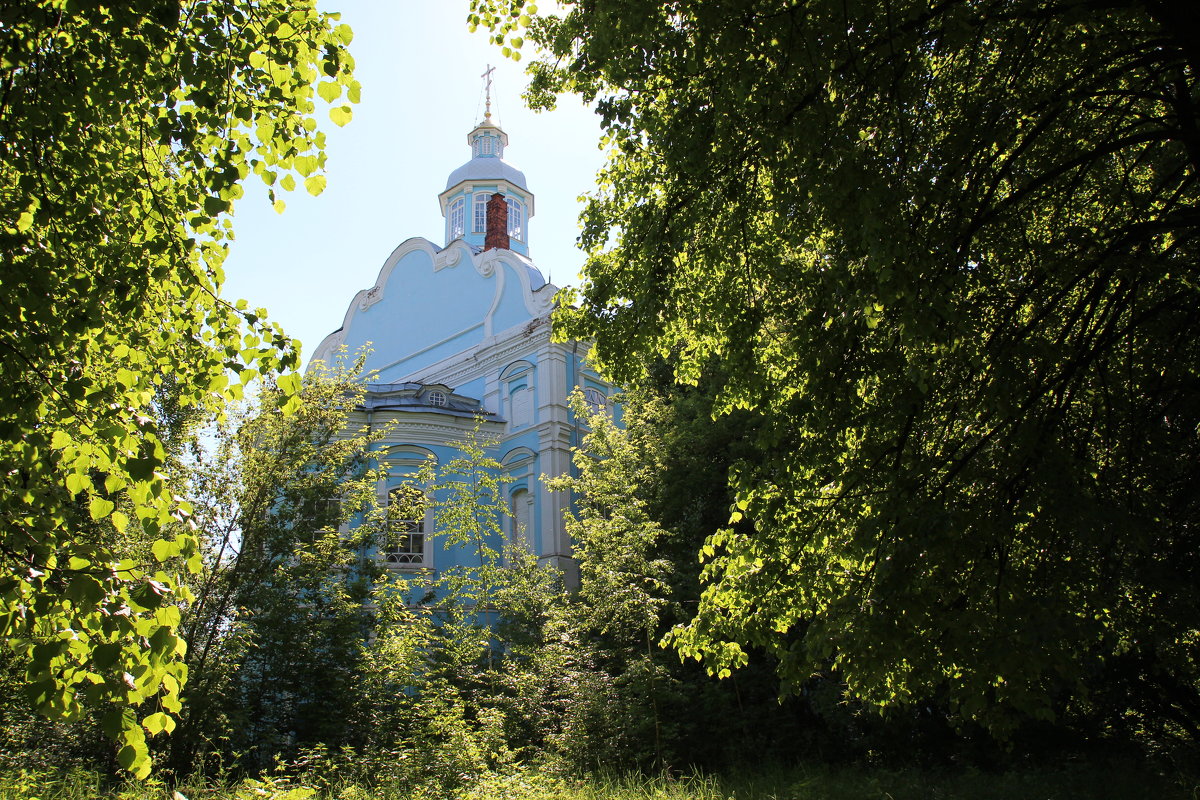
359, 426, 549, 796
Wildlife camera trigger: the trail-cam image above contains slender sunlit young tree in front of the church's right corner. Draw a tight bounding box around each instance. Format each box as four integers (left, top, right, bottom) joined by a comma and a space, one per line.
534, 391, 678, 769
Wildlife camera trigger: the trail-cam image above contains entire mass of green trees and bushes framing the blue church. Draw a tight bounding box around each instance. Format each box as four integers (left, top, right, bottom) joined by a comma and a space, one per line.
0, 0, 1200, 800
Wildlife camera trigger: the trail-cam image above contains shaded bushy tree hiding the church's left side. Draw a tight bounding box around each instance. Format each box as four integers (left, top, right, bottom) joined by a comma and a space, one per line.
170, 360, 385, 774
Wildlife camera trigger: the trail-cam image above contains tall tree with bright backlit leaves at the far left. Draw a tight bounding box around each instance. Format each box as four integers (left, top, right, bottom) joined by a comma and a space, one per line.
0, 0, 359, 775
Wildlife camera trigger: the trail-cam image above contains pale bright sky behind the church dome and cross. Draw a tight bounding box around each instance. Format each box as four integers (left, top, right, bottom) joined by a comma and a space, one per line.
222, 0, 602, 363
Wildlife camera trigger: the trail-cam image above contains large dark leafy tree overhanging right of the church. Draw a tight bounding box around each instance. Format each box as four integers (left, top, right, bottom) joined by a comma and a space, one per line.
474, 0, 1200, 736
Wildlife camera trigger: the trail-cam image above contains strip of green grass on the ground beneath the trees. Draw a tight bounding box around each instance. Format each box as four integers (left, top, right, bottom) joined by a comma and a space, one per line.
0, 764, 1200, 800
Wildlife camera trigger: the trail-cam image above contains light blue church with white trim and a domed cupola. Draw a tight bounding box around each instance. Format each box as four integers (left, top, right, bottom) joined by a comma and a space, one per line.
313, 108, 612, 583
